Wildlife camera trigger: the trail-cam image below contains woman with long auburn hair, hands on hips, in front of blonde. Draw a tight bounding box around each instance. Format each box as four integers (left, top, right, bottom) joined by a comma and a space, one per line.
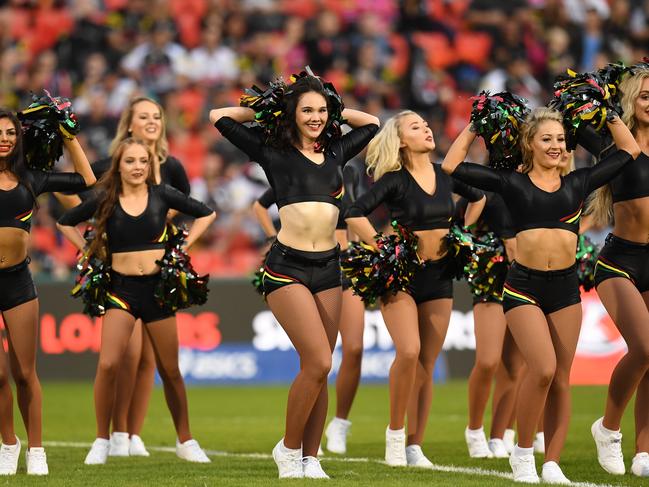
59, 138, 215, 464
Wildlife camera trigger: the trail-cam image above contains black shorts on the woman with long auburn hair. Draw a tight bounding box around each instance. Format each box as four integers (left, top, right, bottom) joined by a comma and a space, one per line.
106, 271, 175, 323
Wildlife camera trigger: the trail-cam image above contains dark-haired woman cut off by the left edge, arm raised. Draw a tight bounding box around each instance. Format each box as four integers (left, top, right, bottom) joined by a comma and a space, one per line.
0, 109, 95, 475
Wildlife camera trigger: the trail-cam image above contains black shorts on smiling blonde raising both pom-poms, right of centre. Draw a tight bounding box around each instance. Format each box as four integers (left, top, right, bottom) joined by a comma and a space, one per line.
503, 262, 581, 315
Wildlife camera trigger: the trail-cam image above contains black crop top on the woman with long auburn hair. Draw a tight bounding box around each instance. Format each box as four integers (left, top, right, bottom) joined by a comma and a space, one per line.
59, 184, 212, 253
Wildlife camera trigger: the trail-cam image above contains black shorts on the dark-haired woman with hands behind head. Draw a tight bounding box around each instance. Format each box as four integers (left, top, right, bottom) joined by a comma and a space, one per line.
262, 240, 341, 295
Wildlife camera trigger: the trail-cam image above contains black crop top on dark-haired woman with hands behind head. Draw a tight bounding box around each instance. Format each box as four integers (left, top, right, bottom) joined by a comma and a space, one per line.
214, 117, 379, 212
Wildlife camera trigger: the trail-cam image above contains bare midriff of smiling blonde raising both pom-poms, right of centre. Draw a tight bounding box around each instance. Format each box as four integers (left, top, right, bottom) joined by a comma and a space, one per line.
516, 228, 577, 271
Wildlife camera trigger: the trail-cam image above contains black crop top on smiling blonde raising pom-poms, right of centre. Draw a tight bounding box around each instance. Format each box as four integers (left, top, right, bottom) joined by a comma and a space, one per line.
453, 150, 633, 238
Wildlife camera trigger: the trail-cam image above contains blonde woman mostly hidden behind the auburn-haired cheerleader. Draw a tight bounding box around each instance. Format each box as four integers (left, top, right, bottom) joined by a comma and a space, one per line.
57, 96, 190, 456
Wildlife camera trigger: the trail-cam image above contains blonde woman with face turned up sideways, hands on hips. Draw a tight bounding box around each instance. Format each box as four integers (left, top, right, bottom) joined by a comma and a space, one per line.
346, 111, 484, 468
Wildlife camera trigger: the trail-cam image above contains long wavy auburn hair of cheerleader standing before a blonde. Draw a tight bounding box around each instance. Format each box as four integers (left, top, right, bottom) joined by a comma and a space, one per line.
88, 137, 155, 260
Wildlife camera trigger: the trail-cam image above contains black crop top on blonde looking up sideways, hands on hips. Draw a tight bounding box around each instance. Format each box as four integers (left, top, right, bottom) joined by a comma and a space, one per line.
346, 164, 484, 231
